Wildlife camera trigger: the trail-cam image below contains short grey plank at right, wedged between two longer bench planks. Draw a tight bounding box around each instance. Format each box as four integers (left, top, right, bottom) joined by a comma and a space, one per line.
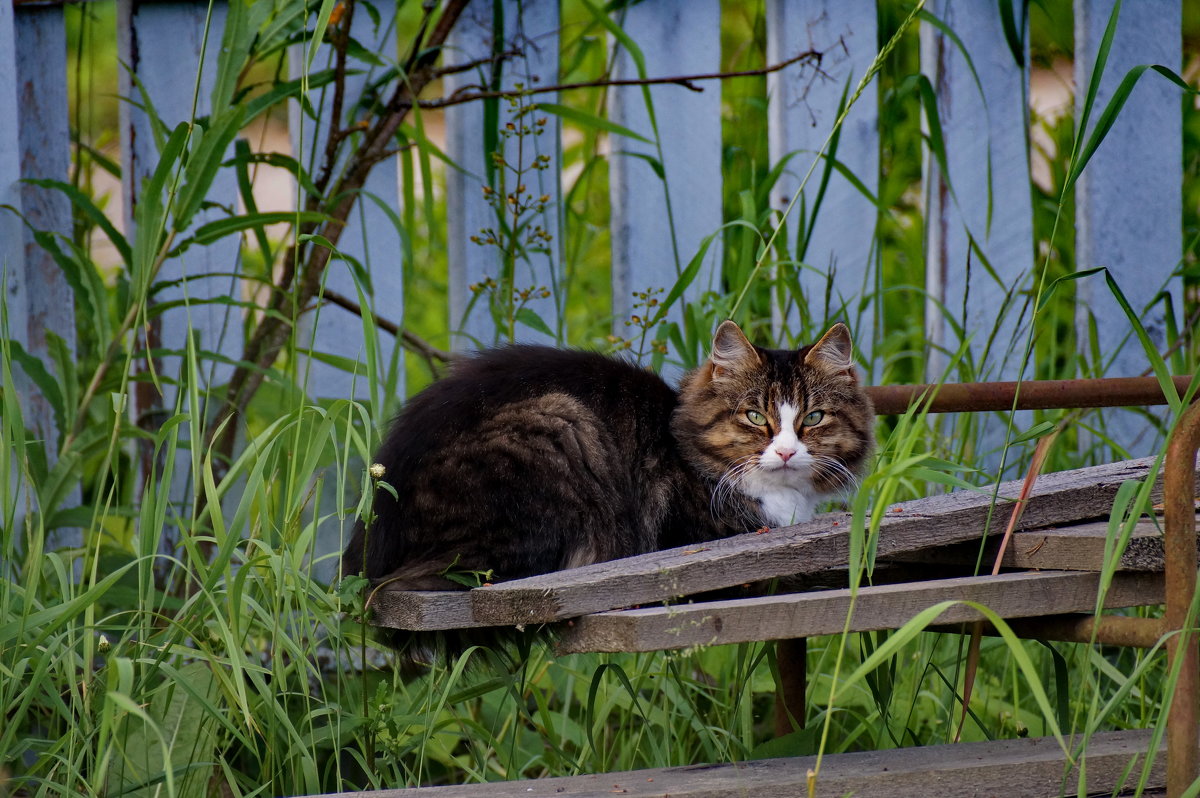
890, 518, 1200, 571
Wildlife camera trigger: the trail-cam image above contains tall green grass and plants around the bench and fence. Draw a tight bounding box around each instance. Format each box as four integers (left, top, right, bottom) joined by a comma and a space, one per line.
0, 0, 1200, 796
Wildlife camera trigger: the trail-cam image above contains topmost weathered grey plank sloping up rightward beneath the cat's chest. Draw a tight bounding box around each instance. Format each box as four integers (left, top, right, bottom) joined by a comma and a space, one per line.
377, 458, 1190, 629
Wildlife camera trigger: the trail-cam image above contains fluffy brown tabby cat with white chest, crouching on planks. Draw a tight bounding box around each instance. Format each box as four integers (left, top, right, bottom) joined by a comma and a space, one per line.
342, 322, 874, 659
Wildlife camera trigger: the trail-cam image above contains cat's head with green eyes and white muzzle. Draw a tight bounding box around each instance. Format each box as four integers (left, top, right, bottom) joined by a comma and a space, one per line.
672, 322, 875, 526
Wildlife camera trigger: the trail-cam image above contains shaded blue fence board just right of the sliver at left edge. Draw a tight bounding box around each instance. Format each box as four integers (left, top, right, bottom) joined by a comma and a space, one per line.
16, 5, 83, 550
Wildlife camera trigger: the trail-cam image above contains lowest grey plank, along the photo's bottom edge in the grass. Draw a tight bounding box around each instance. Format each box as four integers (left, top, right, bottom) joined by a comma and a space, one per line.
312, 730, 1166, 798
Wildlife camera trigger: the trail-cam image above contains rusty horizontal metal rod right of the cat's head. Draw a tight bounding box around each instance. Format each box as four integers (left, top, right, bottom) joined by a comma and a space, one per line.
866, 377, 1192, 415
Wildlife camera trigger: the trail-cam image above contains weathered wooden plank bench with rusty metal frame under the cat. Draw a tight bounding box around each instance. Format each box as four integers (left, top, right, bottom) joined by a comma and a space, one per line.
371, 385, 1200, 798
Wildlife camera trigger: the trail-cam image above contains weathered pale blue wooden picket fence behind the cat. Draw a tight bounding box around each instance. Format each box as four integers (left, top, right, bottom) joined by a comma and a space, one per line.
0, 0, 1182, 472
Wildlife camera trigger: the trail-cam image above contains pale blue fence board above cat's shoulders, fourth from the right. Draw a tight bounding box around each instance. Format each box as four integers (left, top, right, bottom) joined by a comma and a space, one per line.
608, 0, 721, 373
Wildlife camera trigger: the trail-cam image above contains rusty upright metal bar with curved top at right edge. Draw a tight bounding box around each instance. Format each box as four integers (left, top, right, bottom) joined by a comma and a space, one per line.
1163, 404, 1200, 797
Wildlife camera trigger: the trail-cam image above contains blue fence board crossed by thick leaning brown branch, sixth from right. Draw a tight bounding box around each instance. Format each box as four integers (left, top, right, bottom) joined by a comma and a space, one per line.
289, 7, 404, 398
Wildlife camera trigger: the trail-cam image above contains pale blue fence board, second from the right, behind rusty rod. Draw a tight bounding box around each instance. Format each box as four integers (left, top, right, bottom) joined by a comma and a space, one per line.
920, 0, 1033, 478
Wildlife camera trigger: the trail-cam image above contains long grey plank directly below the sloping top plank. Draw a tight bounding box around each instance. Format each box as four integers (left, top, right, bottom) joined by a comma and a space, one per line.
557, 571, 1163, 654
